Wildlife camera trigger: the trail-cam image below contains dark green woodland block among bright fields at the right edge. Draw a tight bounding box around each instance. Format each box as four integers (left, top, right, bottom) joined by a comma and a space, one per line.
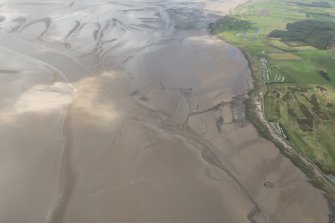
269, 20, 335, 49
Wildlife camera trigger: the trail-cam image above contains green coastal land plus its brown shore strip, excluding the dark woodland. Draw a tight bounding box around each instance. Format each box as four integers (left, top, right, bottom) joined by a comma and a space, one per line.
210, 0, 335, 198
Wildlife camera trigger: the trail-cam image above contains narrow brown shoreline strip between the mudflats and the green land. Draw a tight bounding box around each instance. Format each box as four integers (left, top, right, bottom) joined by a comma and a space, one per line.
208, 0, 335, 199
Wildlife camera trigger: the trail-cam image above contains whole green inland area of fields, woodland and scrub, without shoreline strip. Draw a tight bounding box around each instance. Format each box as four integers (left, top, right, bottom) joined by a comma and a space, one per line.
210, 0, 335, 175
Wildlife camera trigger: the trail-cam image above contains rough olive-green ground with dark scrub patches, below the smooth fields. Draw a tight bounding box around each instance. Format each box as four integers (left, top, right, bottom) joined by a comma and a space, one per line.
265, 84, 335, 174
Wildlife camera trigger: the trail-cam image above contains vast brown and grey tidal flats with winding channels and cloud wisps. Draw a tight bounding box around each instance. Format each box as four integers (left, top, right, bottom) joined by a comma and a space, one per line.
0, 0, 330, 223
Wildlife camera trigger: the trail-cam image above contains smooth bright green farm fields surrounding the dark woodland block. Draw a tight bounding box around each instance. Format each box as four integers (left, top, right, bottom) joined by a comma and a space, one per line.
211, 0, 335, 84
